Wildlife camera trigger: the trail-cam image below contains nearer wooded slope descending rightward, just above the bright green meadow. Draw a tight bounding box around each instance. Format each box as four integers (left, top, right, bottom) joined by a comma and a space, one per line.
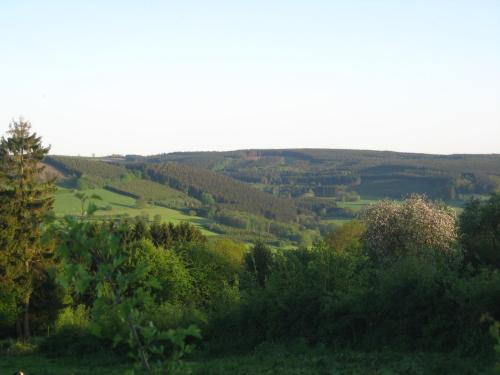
44, 156, 297, 222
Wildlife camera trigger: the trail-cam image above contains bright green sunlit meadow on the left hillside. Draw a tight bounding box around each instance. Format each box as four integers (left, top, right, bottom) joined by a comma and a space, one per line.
54, 188, 215, 236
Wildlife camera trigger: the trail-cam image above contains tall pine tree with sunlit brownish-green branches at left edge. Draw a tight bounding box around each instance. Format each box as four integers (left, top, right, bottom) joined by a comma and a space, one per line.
0, 119, 54, 339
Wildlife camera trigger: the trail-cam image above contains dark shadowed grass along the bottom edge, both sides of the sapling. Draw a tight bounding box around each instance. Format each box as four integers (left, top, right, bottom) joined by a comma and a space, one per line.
0, 344, 495, 375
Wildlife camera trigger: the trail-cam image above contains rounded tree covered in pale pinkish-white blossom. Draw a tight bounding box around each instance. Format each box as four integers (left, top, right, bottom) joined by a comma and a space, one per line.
363, 195, 457, 258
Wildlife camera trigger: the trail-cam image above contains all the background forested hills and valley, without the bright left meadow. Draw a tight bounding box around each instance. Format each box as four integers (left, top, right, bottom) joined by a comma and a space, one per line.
46, 149, 500, 245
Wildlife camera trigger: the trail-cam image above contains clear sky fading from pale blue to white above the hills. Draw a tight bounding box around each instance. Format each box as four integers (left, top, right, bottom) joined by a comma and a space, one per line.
0, 0, 500, 155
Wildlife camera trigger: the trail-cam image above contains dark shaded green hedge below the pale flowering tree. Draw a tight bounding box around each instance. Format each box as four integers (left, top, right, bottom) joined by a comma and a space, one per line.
208, 230, 500, 353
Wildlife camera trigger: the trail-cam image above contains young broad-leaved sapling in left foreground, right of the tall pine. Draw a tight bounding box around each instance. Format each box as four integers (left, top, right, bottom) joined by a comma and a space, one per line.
55, 222, 200, 372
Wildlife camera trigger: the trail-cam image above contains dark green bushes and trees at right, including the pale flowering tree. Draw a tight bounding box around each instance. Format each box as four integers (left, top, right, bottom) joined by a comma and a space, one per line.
208, 195, 500, 355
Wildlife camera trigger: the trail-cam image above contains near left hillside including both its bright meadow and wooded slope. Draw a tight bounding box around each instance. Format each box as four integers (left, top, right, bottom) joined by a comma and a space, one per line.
45, 156, 304, 244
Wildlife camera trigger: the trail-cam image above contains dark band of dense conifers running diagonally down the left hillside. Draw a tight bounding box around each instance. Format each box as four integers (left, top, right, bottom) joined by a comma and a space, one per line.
137, 163, 297, 221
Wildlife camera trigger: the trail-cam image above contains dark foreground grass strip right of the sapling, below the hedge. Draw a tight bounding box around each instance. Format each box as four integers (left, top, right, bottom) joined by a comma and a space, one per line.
192, 344, 495, 375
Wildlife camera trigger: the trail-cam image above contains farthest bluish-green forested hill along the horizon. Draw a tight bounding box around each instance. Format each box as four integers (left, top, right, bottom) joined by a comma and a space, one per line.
124, 149, 500, 199
